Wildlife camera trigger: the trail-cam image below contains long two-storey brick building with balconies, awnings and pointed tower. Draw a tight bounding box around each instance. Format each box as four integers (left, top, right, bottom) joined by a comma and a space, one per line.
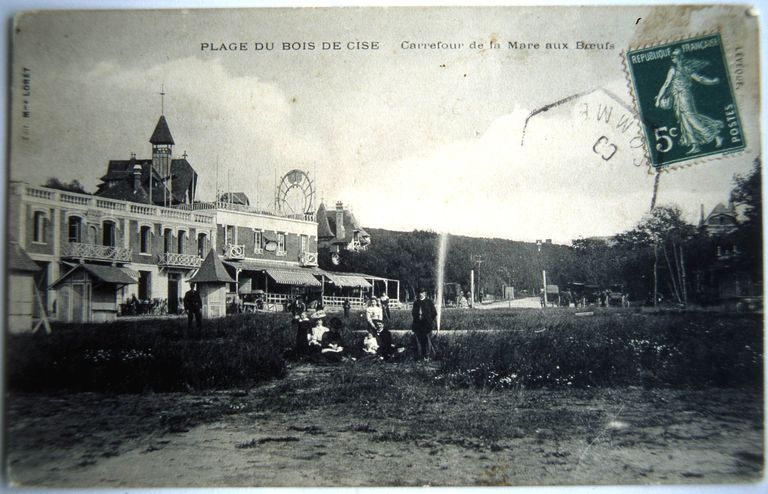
8, 111, 399, 322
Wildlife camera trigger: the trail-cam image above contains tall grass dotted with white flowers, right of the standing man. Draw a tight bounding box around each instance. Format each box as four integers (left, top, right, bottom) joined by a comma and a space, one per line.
438, 310, 763, 389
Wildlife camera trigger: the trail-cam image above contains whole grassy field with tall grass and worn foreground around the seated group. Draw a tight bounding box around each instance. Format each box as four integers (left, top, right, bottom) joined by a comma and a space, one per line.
7, 309, 764, 487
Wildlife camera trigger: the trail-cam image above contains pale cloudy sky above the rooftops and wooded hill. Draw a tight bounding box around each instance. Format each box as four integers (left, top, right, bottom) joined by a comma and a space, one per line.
11, 3, 760, 243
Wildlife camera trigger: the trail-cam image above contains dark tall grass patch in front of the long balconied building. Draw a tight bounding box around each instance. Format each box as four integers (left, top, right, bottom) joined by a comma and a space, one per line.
6, 314, 295, 392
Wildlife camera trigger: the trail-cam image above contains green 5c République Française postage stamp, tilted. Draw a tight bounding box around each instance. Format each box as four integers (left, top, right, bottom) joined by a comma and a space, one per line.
627, 34, 746, 170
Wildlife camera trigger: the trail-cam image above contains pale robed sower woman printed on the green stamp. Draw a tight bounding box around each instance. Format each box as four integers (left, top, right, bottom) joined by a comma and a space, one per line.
655, 49, 725, 154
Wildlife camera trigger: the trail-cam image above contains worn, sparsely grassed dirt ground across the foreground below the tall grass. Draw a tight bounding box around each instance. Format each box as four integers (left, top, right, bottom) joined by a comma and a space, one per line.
7, 363, 763, 487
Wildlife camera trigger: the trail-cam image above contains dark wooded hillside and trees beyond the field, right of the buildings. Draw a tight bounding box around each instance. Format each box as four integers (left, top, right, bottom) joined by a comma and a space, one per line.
320, 160, 762, 304
